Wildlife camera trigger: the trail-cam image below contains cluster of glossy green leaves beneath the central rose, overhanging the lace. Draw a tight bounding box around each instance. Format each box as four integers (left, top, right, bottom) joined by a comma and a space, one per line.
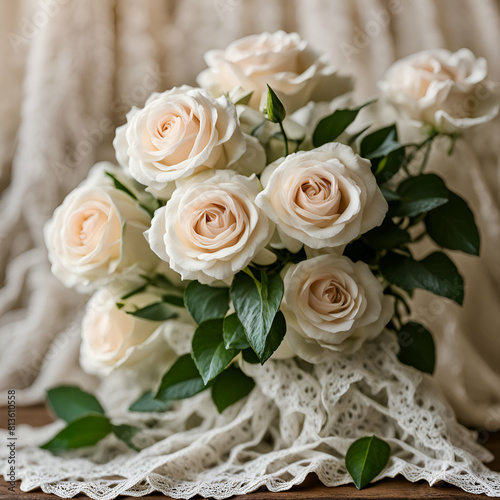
130, 267, 286, 412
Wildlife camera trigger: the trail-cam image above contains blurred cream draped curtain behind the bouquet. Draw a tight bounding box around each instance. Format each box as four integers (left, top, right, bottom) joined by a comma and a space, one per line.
0, 0, 500, 434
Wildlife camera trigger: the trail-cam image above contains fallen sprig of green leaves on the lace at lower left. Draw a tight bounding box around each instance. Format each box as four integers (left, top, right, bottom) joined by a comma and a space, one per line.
41, 386, 140, 452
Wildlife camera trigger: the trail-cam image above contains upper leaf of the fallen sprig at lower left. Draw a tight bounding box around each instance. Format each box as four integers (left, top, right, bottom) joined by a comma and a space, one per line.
47, 386, 104, 423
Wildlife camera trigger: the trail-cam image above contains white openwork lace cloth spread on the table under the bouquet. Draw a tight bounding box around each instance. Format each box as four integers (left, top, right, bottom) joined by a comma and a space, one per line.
0, 333, 500, 500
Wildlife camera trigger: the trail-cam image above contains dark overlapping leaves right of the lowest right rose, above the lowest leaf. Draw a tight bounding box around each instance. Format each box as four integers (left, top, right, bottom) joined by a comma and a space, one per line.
380, 252, 464, 304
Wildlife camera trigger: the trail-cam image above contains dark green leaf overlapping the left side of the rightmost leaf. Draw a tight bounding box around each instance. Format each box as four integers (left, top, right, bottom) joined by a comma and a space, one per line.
391, 174, 449, 217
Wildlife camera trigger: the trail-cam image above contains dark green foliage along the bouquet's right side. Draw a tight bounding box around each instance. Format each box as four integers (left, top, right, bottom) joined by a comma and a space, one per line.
313, 103, 480, 373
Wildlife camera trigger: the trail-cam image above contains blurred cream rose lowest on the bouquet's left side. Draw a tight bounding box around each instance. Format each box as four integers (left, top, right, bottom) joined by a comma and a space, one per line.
80, 282, 195, 376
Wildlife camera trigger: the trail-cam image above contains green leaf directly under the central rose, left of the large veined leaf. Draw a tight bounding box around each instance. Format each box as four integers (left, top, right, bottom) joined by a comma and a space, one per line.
184, 281, 229, 324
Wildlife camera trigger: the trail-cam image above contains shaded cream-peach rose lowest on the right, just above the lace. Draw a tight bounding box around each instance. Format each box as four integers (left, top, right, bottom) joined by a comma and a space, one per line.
281, 254, 394, 363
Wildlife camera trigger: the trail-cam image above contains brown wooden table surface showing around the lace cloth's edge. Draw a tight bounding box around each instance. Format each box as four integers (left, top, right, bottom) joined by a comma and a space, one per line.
0, 406, 500, 500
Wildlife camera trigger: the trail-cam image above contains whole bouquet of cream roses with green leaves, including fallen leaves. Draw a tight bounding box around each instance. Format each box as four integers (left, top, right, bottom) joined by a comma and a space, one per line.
44, 32, 498, 496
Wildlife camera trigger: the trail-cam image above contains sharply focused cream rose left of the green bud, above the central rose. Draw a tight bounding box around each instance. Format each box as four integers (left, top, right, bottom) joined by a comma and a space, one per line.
113, 85, 265, 198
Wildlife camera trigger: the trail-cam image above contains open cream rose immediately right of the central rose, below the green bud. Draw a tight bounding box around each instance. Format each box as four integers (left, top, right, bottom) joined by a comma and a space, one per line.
255, 143, 387, 252
